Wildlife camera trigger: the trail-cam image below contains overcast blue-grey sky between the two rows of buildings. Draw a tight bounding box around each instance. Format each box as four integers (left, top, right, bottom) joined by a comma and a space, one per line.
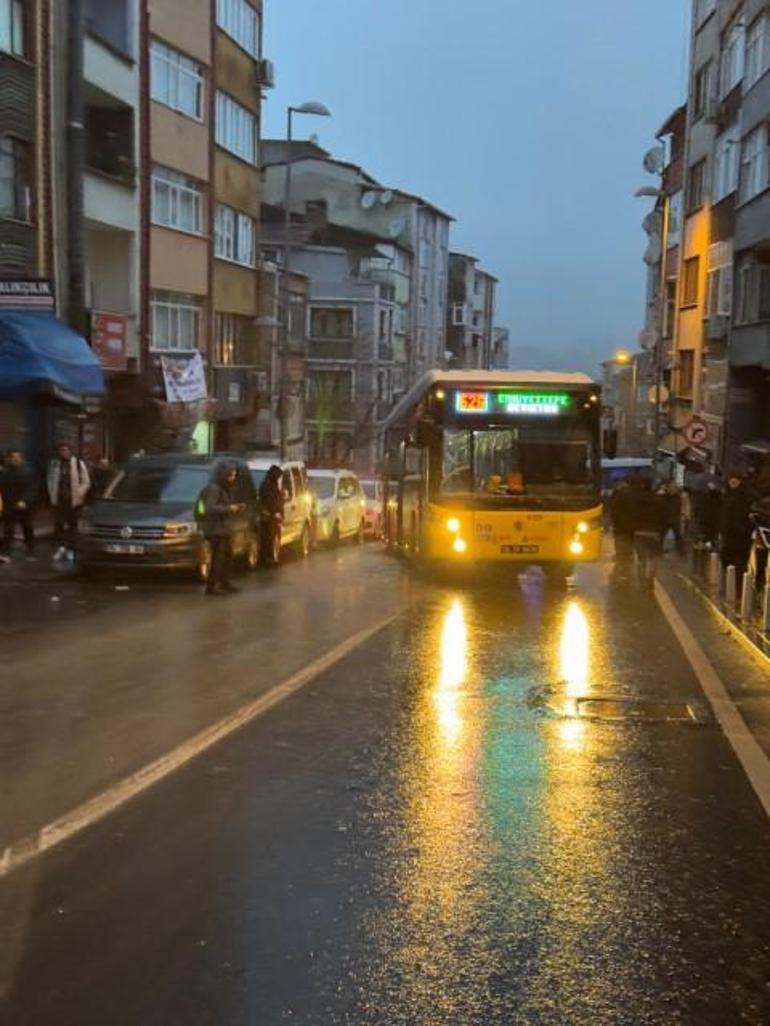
264, 0, 690, 370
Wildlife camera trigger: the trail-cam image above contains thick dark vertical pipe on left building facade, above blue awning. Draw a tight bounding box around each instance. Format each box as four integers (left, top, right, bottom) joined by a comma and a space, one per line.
66, 0, 87, 336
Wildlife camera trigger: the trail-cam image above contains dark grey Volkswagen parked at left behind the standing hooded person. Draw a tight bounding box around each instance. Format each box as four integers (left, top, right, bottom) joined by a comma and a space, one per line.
76, 453, 260, 581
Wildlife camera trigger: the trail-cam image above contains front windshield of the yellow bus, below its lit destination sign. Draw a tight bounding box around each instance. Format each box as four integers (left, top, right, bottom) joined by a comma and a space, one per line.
439, 421, 598, 499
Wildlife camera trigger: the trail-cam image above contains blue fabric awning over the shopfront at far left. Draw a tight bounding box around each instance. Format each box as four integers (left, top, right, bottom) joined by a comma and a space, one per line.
0, 310, 105, 403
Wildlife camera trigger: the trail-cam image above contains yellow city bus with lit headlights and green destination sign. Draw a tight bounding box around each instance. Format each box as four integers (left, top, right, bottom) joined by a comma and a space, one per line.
383, 370, 602, 574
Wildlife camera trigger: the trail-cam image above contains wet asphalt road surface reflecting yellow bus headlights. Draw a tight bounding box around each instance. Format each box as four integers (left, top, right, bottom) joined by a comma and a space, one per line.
0, 549, 770, 1026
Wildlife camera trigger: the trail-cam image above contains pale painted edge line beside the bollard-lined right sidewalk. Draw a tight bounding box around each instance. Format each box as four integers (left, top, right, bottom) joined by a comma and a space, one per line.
655, 581, 770, 816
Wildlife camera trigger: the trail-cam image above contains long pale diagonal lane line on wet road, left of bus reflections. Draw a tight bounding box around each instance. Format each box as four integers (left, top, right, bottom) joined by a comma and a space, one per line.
0, 614, 399, 877
